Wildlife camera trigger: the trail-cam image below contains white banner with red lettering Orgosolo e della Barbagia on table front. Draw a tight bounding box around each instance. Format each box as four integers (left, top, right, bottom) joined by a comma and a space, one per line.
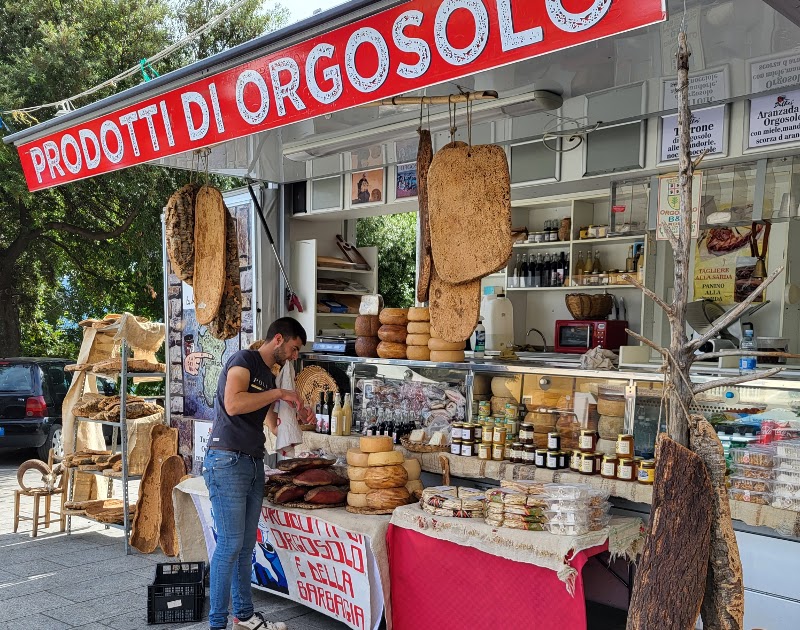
192, 494, 383, 630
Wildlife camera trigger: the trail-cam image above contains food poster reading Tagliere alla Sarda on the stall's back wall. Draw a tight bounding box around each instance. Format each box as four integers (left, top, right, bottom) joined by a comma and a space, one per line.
694, 224, 766, 304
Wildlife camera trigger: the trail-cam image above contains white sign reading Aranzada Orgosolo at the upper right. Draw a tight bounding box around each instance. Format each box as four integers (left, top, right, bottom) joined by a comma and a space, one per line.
747, 90, 800, 149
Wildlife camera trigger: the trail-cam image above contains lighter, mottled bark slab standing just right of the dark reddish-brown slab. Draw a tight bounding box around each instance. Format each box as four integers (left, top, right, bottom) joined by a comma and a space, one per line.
689, 416, 744, 630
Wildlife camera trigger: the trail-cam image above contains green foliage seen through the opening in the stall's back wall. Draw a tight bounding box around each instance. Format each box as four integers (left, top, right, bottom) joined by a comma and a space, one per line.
356, 212, 417, 308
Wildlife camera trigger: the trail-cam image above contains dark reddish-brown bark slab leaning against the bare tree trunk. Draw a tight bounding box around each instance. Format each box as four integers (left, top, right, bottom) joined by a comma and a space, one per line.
627, 434, 714, 630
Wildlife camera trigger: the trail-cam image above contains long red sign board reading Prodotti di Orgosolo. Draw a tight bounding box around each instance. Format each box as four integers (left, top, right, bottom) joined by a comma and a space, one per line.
19, 0, 666, 190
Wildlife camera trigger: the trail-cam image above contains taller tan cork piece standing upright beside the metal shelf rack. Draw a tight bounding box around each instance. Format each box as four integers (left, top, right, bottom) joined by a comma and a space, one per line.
131, 424, 178, 553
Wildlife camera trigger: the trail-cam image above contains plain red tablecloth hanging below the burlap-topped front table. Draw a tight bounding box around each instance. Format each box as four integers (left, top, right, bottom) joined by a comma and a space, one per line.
386, 525, 608, 630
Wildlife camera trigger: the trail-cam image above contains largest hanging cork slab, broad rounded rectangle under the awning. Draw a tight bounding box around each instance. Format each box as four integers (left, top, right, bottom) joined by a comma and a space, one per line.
428, 145, 512, 284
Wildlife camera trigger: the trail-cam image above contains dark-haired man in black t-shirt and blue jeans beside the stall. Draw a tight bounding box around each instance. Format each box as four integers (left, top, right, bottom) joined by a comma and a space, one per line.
203, 317, 310, 630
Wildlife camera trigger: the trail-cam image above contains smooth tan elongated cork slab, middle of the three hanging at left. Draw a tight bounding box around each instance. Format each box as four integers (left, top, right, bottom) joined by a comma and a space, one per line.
194, 186, 227, 325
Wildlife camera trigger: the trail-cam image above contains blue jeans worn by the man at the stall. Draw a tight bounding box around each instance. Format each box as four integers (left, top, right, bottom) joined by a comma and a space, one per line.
203, 449, 264, 628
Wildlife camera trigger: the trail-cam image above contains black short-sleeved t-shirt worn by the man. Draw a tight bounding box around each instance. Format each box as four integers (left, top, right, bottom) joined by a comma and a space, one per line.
209, 350, 275, 458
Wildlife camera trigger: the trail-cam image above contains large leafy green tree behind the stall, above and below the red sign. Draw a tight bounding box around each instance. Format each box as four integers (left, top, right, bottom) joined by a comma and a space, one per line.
0, 0, 287, 356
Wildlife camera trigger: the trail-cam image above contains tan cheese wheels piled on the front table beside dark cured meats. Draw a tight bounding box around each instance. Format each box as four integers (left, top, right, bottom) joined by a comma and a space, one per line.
347, 435, 421, 510
